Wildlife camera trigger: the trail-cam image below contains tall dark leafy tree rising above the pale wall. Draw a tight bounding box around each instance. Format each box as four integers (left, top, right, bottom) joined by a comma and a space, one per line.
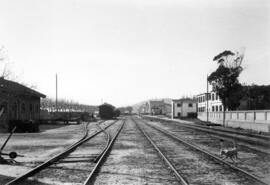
207, 50, 244, 126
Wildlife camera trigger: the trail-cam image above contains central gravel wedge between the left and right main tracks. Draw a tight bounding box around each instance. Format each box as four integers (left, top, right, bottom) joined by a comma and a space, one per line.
95, 119, 178, 185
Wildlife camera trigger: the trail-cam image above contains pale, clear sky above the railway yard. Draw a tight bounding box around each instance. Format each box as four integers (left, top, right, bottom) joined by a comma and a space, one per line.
0, 0, 270, 106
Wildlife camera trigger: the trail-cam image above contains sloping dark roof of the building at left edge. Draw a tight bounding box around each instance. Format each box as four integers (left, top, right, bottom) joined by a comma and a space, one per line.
0, 78, 46, 98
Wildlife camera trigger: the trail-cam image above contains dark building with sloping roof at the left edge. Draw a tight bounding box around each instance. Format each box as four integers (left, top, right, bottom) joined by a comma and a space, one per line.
0, 78, 46, 129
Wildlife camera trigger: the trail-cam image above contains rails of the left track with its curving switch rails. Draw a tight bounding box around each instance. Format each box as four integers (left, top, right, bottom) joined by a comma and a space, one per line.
6, 120, 124, 185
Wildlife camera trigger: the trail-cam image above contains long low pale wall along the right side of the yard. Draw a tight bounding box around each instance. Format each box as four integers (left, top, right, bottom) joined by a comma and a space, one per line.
198, 110, 270, 132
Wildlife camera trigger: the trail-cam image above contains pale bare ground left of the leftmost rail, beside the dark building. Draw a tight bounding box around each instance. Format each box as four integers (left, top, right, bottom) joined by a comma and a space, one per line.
0, 122, 95, 184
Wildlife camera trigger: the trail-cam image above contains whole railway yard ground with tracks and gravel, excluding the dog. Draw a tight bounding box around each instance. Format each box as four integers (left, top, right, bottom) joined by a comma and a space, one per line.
0, 116, 270, 185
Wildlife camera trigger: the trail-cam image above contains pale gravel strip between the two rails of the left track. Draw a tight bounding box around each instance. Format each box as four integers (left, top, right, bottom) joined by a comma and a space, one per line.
24, 121, 121, 185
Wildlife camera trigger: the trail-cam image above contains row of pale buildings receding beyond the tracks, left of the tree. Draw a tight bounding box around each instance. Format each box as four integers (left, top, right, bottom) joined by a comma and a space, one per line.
139, 91, 224, 118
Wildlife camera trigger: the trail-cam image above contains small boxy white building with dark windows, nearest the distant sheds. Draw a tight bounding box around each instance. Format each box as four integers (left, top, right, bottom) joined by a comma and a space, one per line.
172, 98, 197, 119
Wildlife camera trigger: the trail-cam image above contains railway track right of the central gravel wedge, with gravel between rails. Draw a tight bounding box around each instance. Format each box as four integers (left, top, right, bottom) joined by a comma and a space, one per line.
133, 119, 268, 185
